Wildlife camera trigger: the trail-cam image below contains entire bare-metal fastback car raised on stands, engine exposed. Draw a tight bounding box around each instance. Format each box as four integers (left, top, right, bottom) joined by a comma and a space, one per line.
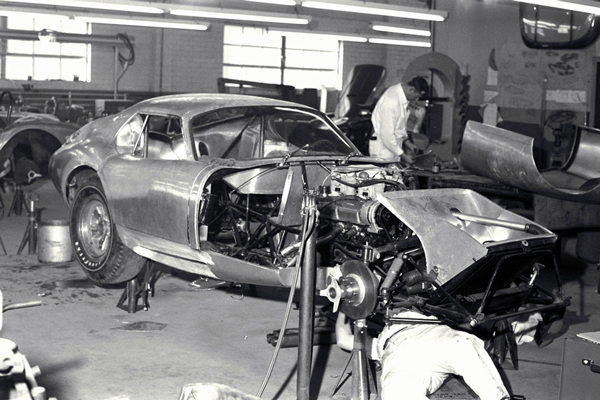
51, 95, 567, 340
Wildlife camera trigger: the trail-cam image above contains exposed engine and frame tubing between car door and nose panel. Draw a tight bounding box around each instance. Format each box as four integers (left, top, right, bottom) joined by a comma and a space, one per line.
200, 165, 410, 268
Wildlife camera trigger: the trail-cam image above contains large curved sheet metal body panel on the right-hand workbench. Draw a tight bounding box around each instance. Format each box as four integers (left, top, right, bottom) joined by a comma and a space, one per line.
461, 121, 600, 204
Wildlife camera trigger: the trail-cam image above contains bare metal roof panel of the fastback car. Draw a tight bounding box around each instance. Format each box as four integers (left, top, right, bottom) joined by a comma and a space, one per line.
132, 93, 309, 116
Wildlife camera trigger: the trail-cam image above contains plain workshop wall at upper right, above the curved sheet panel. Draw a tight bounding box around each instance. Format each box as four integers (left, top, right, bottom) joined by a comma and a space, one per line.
434, 0, 595, 123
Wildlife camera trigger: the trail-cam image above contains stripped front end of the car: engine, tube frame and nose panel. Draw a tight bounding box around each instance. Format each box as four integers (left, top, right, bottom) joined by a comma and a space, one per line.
199, 159, 568, 354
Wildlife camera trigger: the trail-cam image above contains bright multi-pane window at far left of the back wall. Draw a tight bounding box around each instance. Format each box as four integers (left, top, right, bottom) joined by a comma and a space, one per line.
2, 14, 91, 82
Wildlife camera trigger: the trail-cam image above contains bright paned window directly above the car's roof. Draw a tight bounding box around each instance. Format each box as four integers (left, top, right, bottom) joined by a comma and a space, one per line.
223, 26, 342, 89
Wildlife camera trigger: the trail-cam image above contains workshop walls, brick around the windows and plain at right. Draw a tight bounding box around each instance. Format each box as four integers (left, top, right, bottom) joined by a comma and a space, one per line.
0, 0, 597, 124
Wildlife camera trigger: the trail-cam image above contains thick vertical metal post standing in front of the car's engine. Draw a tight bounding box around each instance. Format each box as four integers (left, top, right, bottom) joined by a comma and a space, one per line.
296, 195, 317, 400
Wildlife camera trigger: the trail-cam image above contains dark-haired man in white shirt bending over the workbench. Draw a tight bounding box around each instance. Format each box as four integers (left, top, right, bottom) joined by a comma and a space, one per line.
369, 76, 429, 164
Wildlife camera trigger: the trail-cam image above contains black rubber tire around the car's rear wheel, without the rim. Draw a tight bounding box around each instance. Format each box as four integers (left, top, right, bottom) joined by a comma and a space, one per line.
70, 175, 146, 284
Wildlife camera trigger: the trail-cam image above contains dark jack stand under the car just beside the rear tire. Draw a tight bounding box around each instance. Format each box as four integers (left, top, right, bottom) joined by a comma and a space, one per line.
117, 260, 162, 314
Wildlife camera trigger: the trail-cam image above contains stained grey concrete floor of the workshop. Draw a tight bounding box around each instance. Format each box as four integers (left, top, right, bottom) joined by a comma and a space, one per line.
0, 180, 600, 400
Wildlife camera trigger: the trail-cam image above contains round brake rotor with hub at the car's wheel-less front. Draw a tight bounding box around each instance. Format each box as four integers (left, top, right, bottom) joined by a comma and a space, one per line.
340, 260, 379, 319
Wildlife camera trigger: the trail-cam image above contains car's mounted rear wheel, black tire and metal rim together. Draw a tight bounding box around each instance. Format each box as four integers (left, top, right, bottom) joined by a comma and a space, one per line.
70, 175, 146, 284
